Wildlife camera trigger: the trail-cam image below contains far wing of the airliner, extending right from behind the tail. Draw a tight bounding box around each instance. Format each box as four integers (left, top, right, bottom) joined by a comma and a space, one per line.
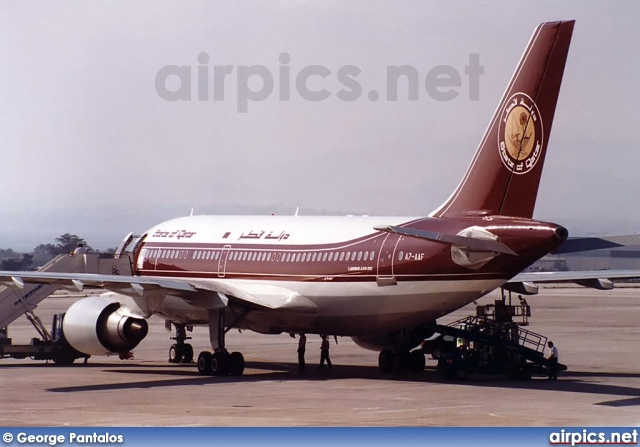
503, 270, 640, 295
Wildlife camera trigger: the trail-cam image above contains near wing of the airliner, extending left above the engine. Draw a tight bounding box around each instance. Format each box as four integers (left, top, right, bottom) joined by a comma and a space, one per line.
0, 271, 319, 313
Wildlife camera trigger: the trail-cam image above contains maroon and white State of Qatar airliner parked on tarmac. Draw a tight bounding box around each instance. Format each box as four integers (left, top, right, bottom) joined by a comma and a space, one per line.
0, 21, 575, 376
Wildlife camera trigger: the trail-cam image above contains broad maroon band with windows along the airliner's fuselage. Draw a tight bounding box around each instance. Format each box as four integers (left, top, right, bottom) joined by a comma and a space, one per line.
136, 217, 555, 282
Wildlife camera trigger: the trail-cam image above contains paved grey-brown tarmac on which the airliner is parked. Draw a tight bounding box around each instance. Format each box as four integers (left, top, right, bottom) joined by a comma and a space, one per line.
0, 286, 640, 427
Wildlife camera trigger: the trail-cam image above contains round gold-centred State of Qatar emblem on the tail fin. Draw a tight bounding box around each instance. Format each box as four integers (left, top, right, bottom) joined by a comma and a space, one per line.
498, 93, 543, 174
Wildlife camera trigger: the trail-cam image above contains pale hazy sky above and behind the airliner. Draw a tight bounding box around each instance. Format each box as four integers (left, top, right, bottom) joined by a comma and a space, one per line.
0, 0, 640, 249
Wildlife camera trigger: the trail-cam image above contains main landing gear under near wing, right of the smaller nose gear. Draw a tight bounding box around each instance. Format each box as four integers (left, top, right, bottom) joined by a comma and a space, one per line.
198, 309, 246, 376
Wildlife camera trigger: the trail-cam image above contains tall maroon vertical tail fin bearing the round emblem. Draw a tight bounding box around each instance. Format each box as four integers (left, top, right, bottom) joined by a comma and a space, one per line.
431, 21, 575, 218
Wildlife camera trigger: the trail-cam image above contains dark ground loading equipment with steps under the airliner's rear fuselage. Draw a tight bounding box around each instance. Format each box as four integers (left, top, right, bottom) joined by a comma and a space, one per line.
423, 296, 567, 380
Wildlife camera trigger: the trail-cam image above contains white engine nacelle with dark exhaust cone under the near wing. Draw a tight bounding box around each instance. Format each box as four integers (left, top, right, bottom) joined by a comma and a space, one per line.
62, 294, 149, 355
